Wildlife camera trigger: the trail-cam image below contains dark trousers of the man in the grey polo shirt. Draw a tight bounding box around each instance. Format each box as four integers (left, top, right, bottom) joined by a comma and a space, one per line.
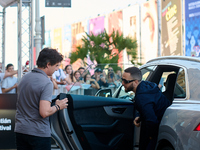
16, 133, 51, 150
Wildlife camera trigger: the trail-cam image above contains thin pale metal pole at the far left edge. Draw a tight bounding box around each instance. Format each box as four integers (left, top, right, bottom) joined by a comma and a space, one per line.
2, 8, 6, 72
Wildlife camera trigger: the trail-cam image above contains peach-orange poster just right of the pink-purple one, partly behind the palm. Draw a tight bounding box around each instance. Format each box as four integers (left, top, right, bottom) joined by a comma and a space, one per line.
108, 11, 123, 64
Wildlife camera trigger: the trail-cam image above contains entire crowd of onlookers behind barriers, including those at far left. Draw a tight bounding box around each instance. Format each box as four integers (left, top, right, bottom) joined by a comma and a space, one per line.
0, 64, 122, 94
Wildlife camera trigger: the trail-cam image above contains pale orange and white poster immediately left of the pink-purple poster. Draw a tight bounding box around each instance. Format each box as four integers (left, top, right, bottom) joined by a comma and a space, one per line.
71, 20, 89, 52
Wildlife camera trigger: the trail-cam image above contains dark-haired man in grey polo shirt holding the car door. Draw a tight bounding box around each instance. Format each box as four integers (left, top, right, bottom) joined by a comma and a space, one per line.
15, 48, 68, 150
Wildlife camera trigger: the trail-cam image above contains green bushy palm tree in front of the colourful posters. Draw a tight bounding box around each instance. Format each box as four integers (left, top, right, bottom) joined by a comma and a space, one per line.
70, 30, 137, 68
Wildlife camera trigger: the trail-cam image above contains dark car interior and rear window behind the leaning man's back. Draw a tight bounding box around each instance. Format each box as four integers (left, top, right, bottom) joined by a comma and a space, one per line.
148, 65, 186, 103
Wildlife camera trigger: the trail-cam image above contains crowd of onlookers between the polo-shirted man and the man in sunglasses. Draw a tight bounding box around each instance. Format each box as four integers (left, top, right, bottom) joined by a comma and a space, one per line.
51, 65, 122, 89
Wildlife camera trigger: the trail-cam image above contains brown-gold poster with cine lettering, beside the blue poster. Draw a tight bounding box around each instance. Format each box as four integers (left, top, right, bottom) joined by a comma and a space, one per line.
161, 0, 183, 56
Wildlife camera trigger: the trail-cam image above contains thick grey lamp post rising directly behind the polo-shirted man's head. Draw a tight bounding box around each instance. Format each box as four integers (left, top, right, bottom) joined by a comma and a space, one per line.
35, 0, 42, 60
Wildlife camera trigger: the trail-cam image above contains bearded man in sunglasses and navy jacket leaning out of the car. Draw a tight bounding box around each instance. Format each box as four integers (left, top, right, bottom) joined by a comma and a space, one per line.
122, 67, 171, 150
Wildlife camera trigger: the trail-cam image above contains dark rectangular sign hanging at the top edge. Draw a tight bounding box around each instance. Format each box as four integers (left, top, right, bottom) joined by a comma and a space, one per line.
45, 0, 71, 7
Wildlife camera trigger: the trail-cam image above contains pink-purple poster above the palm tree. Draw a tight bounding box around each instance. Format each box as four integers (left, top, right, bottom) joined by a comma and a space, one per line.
89, 16, 104, 35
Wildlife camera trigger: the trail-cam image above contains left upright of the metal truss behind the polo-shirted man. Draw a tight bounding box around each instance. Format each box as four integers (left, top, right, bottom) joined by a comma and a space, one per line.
18, 0, 22, 81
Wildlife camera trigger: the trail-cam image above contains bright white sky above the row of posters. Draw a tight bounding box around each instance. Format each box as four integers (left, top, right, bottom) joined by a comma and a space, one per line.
40, 0, 146, 29
